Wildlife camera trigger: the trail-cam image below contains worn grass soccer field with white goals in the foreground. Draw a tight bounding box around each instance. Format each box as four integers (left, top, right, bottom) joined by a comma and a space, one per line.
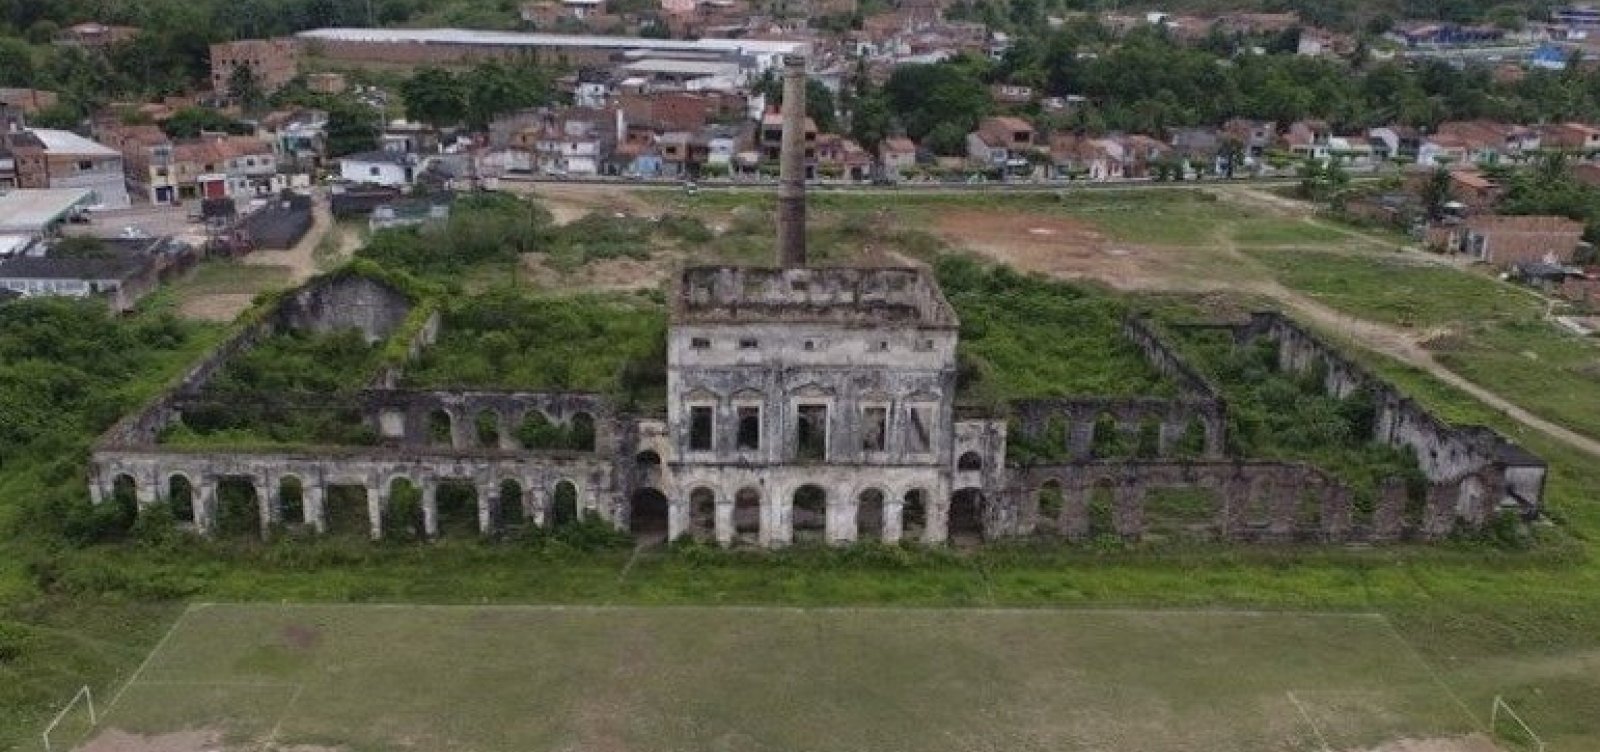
56, 605, 1478, 752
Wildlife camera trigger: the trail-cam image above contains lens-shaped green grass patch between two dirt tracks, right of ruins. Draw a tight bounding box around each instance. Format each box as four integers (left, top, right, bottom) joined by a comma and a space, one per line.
1246, 250, 1542, 326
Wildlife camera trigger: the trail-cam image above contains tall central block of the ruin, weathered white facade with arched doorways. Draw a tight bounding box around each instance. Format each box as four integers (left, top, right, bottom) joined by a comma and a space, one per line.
640, 267, 1005, 546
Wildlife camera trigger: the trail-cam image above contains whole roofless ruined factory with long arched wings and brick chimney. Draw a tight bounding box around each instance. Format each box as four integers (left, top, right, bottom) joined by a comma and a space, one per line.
90, 56, 1546, 547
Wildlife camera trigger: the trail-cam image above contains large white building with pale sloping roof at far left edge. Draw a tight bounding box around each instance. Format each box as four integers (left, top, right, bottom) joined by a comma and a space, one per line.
0, 128, 128, 208
